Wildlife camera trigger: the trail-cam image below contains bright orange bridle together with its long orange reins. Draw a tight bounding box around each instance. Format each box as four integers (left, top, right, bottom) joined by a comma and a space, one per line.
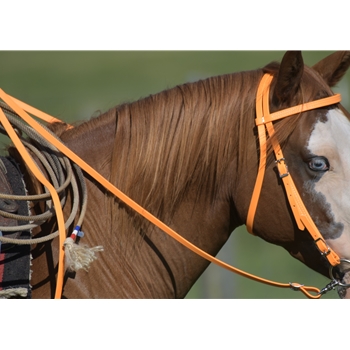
0, 76, 340, 299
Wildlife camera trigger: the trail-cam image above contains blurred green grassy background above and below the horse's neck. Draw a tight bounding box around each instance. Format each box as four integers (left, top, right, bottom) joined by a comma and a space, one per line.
0, 51, 350, 299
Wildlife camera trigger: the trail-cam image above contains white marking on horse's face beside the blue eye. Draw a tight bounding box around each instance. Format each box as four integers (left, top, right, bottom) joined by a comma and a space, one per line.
307, 109, 350, 298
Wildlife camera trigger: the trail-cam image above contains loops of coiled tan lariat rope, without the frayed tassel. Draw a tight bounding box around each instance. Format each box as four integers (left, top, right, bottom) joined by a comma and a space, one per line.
0, 103, 87, 239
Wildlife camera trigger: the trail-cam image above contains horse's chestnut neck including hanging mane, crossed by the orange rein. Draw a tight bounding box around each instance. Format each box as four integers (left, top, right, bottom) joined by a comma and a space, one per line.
33, 72, 255, 298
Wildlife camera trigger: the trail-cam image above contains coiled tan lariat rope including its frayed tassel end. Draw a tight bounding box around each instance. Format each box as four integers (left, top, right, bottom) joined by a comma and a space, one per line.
0, 102, 102, 297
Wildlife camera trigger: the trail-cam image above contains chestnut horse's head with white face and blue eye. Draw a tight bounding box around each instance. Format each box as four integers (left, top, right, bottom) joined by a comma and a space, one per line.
245, 52, 350, 295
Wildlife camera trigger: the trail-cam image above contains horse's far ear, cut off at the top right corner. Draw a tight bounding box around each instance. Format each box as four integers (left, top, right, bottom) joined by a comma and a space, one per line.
312, 51, 350, 87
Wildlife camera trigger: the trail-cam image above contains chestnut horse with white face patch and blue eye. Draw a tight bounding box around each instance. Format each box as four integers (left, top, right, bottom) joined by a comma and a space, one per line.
0, 52, 350, 298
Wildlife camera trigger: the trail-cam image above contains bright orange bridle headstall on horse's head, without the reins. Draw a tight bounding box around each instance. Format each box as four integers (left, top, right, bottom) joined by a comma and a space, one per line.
246, 74, 341, 266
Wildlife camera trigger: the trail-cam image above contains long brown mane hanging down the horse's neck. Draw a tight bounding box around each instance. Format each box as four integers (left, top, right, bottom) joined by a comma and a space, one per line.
56, 71, 262, 224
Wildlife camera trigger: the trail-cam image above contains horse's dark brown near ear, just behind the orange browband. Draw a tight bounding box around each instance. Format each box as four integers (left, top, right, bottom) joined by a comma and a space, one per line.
273, 51, 304, 105
